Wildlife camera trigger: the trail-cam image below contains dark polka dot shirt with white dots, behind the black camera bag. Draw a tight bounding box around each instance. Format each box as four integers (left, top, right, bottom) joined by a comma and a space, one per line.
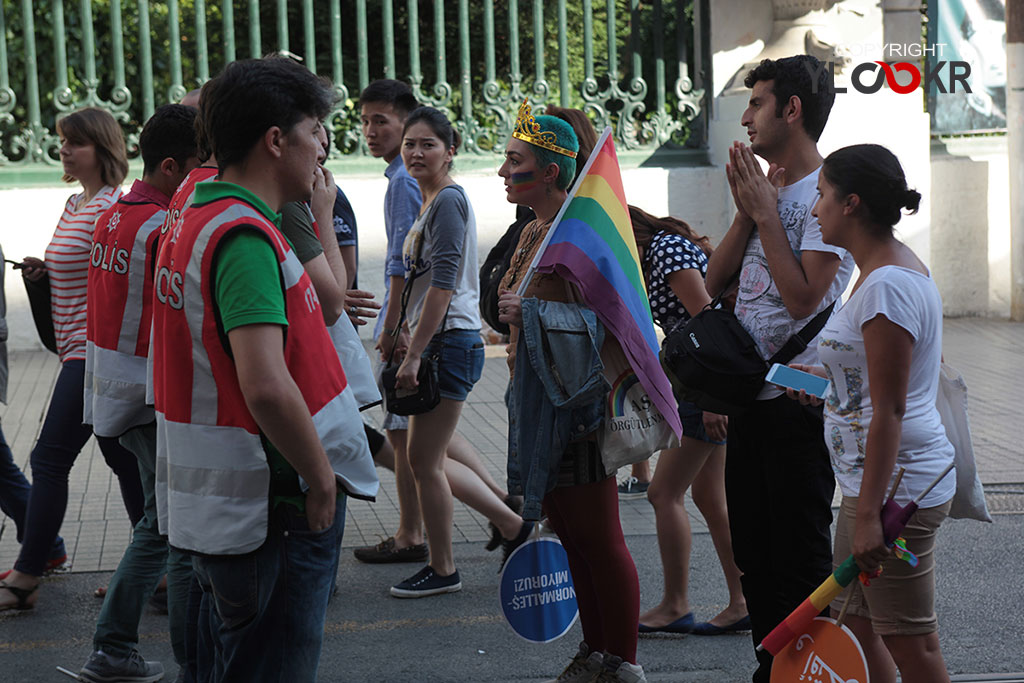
643, 230, 708, 334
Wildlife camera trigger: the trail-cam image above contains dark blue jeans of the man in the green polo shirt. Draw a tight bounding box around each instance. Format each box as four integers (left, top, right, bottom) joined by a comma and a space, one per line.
193, 497, 345, 683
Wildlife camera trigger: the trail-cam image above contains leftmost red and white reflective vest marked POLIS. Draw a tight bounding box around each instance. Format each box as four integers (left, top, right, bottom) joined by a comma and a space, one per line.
82, 180, 169, 436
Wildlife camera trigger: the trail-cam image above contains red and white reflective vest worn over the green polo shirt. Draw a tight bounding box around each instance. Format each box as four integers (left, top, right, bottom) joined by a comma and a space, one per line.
153, 183, 378, 555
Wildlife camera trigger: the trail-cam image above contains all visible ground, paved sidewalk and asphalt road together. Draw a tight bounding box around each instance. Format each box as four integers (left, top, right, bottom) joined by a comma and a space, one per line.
0, 319, 1024, 683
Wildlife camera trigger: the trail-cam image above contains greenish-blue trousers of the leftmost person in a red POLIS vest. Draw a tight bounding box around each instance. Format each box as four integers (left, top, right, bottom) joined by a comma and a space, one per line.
93, 423, 193, 666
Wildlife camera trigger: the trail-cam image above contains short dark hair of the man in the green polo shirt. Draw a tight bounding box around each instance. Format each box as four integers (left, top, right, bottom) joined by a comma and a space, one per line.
200, 57, 337, 171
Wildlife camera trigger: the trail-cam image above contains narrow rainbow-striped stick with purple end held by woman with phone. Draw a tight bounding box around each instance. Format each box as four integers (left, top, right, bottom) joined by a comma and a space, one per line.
757, 463, 953, 656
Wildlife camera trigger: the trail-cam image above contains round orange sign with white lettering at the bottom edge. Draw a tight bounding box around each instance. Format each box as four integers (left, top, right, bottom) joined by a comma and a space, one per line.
771, 616, 870, 683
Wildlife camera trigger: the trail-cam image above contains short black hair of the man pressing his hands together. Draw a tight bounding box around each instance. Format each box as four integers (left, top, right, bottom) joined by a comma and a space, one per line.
743, 54, 836, 142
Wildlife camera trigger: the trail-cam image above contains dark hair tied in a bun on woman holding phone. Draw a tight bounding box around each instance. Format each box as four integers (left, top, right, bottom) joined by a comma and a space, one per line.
821, 144, 921, 234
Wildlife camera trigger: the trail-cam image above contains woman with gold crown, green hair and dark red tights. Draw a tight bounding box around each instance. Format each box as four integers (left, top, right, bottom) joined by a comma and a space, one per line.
498, 100, 646, 683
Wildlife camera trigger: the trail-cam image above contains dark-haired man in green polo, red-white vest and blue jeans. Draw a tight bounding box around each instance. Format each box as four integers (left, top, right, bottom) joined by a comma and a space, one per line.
153, 57, 378, 681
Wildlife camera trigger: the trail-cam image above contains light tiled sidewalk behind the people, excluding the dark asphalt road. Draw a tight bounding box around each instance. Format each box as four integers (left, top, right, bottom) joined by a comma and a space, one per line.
0, 318, 1024, 571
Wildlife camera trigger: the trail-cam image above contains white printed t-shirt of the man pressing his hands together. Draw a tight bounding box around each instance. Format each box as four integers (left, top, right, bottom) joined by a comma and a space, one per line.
735, 167, 854, 399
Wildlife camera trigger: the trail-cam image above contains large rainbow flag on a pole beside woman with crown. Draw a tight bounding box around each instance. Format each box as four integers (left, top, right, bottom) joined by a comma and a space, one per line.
522, 127, 682, 436
